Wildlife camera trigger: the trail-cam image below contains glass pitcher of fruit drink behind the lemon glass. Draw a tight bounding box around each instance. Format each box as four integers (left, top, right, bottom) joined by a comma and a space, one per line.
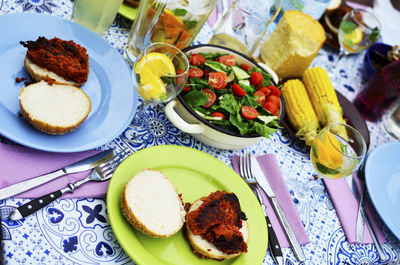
125, 0, 218, 62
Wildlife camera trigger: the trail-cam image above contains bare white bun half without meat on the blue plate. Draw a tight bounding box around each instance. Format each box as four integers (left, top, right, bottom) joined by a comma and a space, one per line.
19, 81, 91, 135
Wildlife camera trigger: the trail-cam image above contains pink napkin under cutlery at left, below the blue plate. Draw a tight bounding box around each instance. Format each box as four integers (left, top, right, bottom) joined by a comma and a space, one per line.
0, 143, 108, 198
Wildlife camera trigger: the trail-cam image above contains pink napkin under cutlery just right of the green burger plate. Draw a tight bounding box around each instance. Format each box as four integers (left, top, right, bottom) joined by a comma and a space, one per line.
231, 154, 310, 248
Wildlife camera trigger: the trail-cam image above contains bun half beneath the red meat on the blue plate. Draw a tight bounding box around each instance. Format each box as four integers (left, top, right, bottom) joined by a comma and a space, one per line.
24, 56, 86, 87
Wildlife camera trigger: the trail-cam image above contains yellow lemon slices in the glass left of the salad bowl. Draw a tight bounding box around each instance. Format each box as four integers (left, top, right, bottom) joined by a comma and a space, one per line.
135, 52, 176, 101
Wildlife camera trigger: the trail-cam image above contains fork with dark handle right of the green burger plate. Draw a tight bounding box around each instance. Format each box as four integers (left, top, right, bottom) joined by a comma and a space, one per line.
239, 154, 283, 265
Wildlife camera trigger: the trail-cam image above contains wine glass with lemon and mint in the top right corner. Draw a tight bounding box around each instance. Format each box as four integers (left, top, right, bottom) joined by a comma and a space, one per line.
338, 9, 381, 60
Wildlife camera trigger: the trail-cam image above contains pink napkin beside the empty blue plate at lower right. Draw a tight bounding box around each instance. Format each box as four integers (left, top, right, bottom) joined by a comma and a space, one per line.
323, 174, 386, 244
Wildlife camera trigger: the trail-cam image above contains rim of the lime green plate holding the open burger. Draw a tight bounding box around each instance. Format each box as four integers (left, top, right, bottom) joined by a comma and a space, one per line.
106, 145, 268, 264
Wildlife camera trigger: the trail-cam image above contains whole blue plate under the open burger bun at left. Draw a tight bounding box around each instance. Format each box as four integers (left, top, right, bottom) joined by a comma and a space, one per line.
0, 13, 138, 153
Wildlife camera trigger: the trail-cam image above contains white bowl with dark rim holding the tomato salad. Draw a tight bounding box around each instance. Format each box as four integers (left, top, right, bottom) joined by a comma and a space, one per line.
165, 44, 284, 150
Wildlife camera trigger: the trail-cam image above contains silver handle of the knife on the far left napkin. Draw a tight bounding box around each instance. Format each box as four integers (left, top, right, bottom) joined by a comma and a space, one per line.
0, 169, 65, 200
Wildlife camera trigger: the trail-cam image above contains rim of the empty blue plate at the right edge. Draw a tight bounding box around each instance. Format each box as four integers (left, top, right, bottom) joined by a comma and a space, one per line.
365, 141, 400, 239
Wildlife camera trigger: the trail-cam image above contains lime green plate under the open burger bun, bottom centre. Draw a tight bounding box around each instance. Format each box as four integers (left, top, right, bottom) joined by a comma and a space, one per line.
107, 145, 268, 265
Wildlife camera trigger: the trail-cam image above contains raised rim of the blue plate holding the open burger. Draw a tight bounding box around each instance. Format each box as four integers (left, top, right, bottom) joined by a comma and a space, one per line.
0, 13, 138, 153
